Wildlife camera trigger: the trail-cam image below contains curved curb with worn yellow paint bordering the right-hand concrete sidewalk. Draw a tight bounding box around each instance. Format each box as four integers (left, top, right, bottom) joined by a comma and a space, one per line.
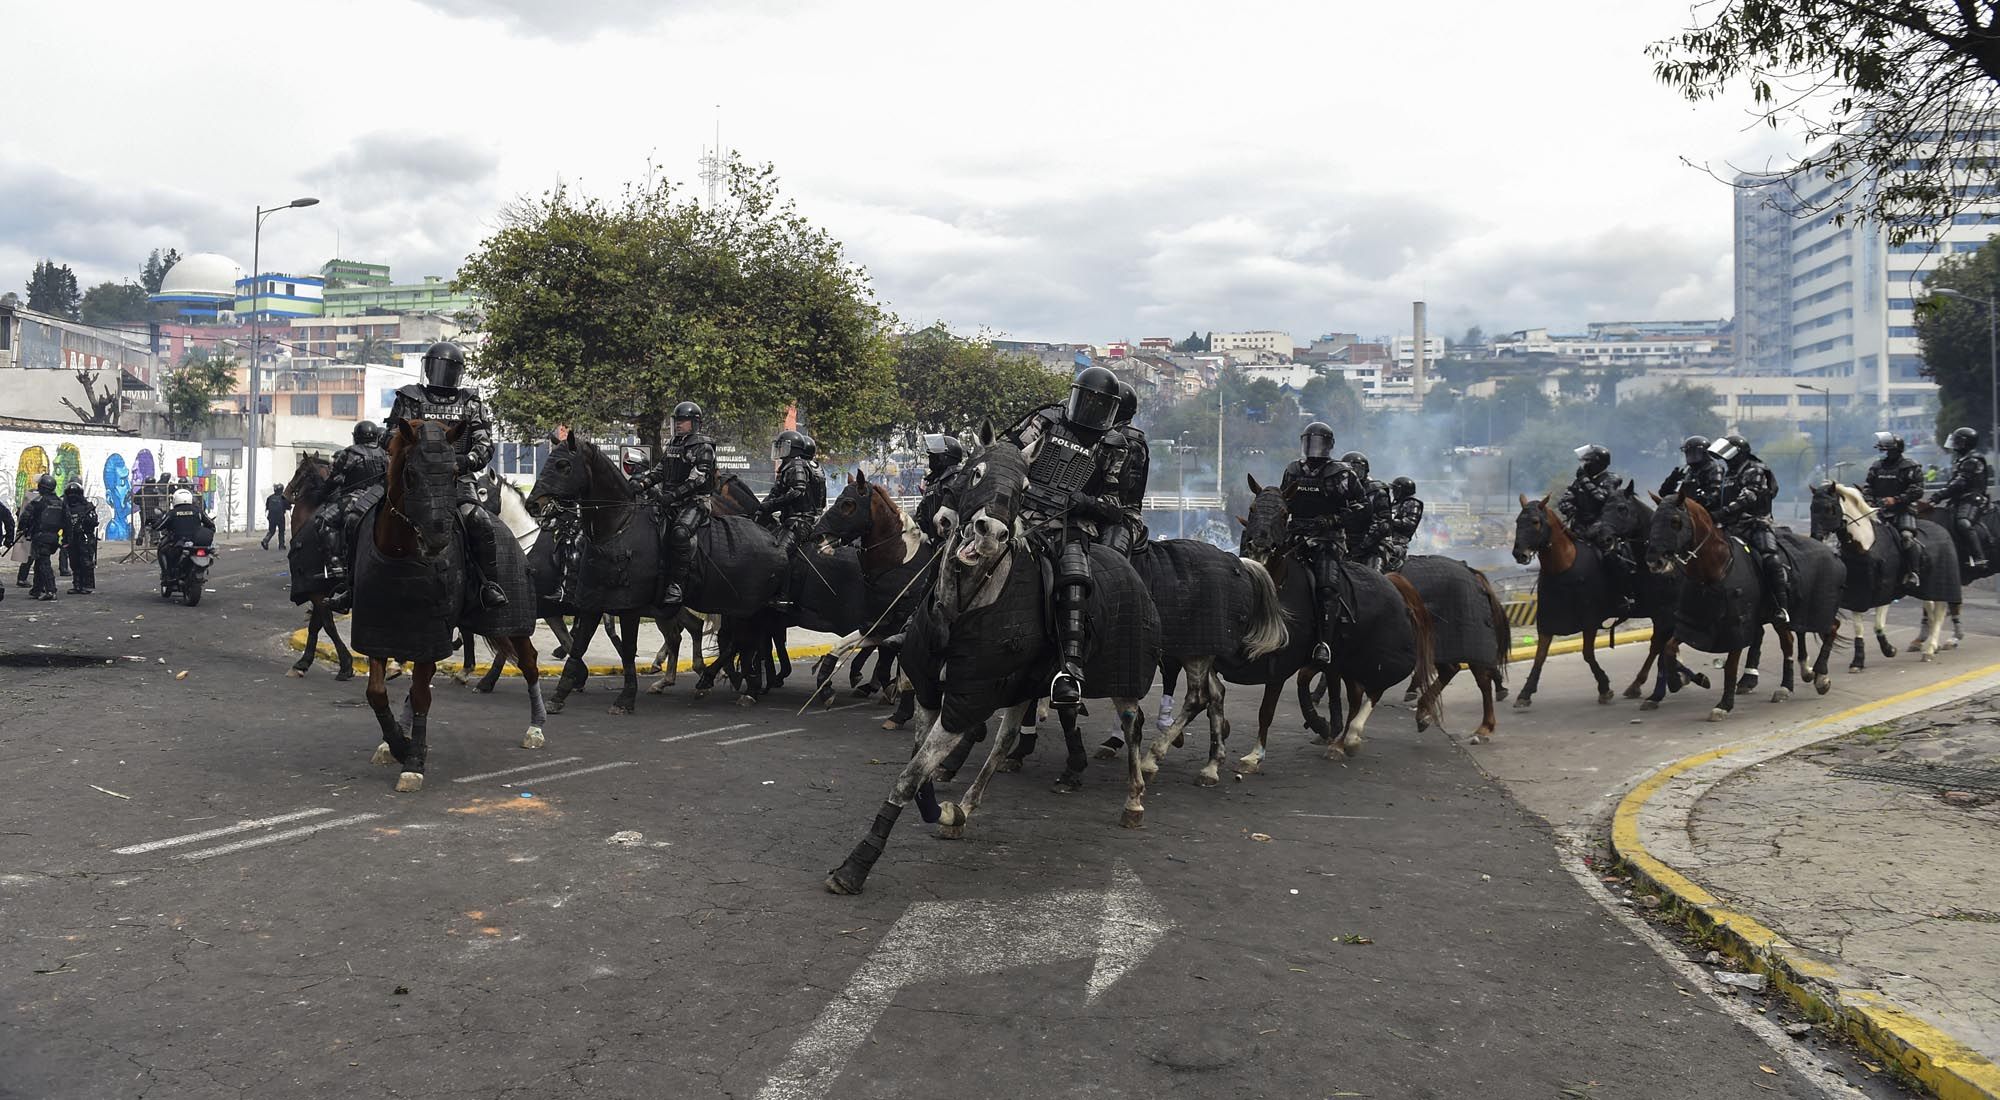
1612, 664, 2000, 1100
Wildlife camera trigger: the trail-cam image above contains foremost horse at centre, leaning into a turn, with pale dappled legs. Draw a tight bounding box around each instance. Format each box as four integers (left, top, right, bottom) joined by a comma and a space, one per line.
824, 432, 1160, 894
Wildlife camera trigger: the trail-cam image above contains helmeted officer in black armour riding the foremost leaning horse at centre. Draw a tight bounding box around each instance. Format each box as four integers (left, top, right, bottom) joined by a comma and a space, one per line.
1010, 366, 1120, 706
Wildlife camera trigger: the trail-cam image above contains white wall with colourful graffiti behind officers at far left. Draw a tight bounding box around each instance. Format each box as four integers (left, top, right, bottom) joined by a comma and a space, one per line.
0, 430, 200, 538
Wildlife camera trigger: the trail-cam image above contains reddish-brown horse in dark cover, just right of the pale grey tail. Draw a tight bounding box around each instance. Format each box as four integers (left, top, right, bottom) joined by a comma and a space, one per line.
1226, 476, 1436, 772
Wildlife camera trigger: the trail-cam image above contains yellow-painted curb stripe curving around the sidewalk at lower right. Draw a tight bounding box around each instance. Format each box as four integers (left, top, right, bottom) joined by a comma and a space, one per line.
1612, 664, 2000, 1100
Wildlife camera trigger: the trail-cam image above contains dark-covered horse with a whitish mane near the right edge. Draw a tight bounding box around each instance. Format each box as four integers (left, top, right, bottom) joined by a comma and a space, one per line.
1808, 482, 1960, 672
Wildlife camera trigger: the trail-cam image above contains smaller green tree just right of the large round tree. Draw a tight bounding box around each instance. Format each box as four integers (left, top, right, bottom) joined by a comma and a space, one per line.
888, 320, 1070, 432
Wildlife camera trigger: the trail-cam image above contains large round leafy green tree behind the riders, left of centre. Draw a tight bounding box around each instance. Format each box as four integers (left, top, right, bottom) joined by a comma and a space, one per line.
454, 158, 898, 450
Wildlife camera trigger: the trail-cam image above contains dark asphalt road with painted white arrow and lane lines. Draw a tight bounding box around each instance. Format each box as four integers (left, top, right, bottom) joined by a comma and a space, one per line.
0, 550, 1872, 1100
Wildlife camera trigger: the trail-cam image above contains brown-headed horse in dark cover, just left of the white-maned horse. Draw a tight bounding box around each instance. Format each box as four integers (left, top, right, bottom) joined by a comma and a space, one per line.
1646, 494, 1846, 722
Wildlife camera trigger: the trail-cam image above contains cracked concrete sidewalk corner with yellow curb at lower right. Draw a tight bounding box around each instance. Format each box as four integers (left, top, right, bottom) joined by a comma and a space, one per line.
1612, 666, 2000, 1100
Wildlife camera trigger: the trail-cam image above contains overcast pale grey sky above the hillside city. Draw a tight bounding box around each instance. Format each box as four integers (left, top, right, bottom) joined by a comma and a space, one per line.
0, 0, 1784, 342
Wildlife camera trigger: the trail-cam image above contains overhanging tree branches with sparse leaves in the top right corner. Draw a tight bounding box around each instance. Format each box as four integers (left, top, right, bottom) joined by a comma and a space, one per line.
1648, 0, 2000, 244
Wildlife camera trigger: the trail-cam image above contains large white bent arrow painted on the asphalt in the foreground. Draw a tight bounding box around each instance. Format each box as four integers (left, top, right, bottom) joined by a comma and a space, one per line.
756, 864, 1174, 1100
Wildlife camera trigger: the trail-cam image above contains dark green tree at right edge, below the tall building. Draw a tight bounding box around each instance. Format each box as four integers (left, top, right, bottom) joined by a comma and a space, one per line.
1916, 238, 2000, 436
